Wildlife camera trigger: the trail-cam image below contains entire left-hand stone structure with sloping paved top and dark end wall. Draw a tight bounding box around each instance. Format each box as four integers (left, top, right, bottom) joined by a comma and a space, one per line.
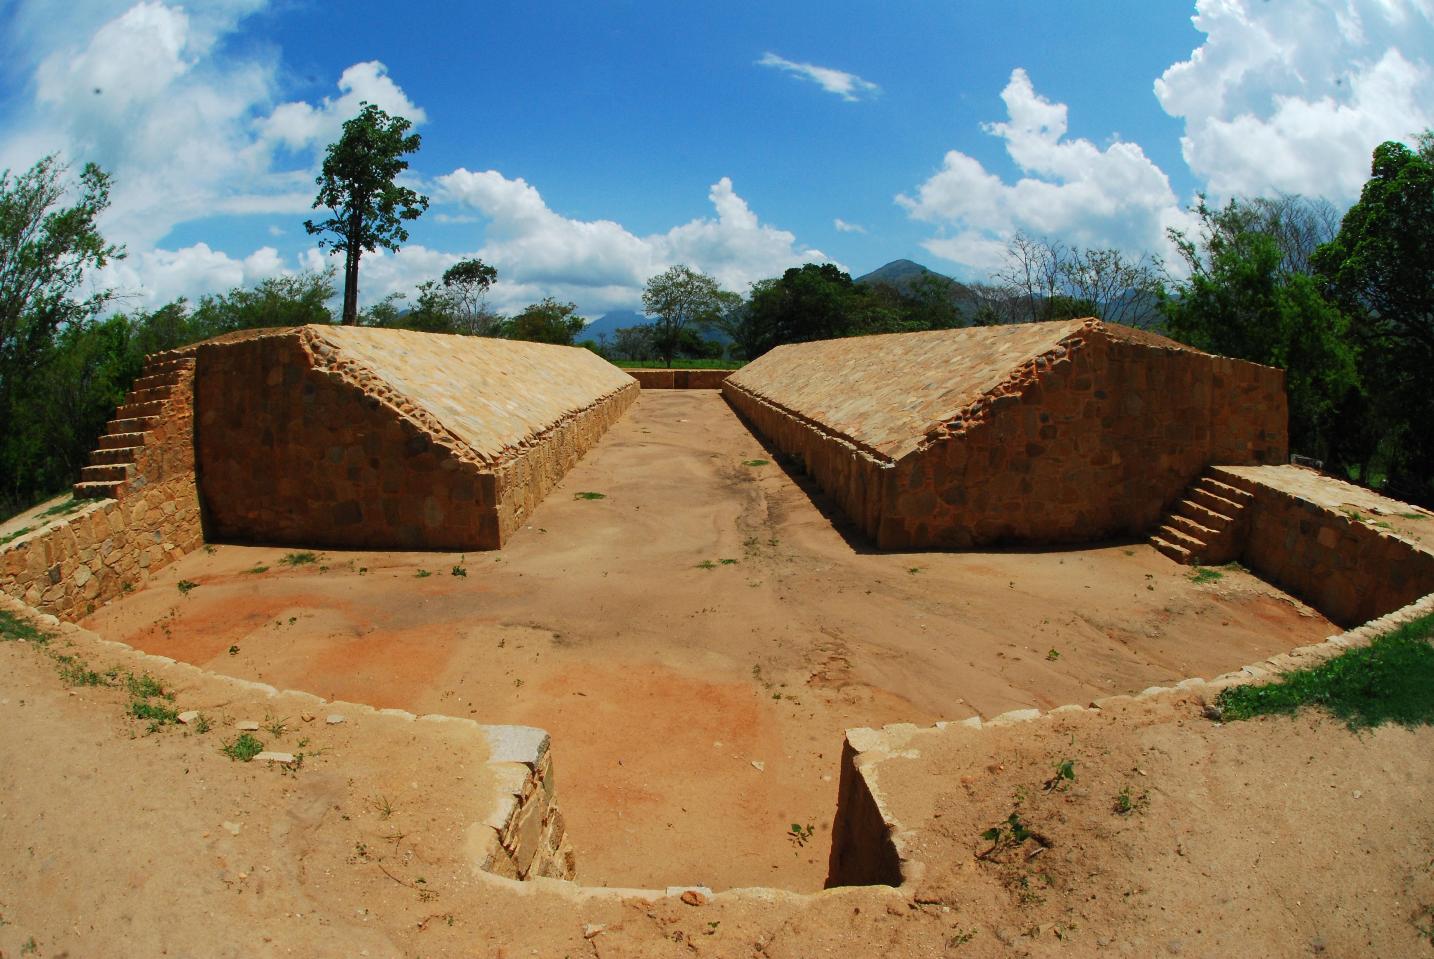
195, 327, 638, 549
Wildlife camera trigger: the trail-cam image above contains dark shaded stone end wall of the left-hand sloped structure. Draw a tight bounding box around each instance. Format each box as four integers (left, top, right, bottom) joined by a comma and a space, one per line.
195, 331, 500, 549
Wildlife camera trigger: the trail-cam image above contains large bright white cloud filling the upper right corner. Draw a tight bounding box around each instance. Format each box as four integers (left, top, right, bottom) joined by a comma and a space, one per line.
1154, 0, 1434, 202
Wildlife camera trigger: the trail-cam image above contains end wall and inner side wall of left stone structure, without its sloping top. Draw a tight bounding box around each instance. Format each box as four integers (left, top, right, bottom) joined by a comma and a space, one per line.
196, 330, 638, 550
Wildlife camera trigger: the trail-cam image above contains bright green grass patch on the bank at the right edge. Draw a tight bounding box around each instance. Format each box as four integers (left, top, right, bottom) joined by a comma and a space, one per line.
1216, 614, 1434, 730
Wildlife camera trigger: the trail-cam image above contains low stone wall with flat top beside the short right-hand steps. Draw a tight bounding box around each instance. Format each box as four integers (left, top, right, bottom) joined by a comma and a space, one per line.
1212, 467, 1434, 626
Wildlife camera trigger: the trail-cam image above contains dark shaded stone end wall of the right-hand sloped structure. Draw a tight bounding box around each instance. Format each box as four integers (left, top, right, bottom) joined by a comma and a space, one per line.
876, 328, 1288, 549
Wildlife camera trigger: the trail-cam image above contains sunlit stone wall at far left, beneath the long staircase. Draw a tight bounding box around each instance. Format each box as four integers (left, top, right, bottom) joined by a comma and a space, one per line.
0, 356, 204, 619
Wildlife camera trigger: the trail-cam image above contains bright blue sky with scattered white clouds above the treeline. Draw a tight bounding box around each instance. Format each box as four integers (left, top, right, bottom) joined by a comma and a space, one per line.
0, 0, 1434, 315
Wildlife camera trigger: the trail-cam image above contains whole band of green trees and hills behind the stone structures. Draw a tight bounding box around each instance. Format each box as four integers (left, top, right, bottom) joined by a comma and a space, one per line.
0, 133, 1434, 515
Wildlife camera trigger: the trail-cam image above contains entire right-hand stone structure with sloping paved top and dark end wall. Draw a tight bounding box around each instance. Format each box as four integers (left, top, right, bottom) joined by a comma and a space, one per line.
723, 320, 1288, 549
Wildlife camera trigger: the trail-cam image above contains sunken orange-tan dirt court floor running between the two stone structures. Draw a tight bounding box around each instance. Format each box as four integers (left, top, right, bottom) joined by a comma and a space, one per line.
85, 391, 1338, 890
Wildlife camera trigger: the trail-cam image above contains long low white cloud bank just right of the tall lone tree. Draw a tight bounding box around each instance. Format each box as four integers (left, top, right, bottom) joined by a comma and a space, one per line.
437, 168, 826, 311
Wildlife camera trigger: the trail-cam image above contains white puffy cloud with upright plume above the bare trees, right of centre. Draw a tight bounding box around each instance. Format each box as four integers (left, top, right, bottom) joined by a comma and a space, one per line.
896, 69, 1184, 271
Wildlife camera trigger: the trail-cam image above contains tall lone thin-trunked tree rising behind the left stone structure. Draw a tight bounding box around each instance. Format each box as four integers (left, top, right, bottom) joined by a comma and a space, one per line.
304, 103, 429, 325
